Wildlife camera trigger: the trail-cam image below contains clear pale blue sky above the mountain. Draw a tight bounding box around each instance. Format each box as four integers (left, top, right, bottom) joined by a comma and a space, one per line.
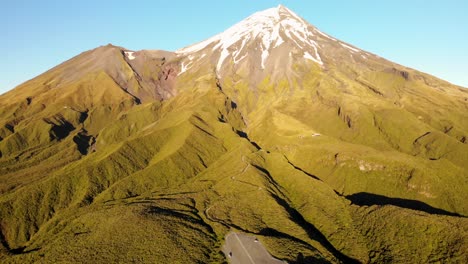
0, 0, 468, 94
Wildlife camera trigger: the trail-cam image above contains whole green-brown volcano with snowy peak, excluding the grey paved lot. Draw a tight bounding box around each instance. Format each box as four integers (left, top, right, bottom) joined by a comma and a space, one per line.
0, 6, 468, 263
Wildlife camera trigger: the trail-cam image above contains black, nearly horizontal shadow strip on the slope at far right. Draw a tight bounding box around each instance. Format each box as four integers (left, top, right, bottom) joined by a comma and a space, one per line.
345, 192, 464, 217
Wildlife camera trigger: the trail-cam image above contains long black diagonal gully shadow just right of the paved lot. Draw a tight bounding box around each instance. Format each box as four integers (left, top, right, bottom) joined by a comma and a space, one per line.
272, 194, 360, 263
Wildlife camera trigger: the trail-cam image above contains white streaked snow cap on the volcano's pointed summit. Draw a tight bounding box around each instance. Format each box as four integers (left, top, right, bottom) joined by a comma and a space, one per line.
176, 5, 323, 72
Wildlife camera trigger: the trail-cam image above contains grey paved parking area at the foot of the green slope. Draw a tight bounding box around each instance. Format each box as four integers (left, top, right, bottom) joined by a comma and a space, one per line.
223, 232, 285, 264
